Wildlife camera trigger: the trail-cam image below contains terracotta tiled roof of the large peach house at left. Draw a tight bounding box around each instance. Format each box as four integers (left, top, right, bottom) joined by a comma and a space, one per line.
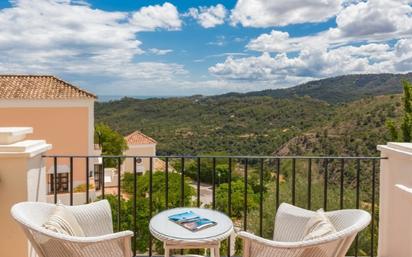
0, 75, 96, 100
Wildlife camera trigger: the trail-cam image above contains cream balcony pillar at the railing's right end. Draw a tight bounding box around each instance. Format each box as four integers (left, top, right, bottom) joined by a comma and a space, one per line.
378, 143, 412, 257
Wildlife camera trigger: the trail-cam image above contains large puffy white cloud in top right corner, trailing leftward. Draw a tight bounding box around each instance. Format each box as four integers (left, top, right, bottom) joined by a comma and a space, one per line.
246, 0, 412, 52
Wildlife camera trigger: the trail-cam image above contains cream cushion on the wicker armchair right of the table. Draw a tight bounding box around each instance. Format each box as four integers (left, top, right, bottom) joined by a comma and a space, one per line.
303, 209, 336, 240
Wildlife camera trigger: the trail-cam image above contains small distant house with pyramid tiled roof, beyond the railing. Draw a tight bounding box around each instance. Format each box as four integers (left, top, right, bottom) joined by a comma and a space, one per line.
122, 131, 166, 174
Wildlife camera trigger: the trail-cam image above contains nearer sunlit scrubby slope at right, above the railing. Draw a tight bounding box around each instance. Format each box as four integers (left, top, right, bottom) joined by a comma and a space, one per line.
274, 94, 401, 156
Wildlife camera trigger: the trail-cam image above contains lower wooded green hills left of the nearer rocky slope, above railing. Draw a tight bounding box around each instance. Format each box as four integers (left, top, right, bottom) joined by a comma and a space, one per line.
96, 96, 335, 155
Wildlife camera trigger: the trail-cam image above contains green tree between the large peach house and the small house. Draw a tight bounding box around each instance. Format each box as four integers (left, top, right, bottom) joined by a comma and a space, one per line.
94, 123, 127, 167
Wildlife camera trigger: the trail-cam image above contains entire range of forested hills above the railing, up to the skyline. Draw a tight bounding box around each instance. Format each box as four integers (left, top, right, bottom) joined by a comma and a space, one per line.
96, 73, 412, 155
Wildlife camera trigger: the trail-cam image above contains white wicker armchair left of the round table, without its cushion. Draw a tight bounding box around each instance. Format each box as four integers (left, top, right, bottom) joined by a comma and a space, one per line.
11, 200, 133, 257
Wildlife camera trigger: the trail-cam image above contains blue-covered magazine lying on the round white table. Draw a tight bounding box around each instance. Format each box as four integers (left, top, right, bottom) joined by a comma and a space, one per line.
169, 211, 217, 232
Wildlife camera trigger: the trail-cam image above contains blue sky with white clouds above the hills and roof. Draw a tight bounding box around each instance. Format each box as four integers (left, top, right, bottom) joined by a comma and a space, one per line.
0, 0, 412, 96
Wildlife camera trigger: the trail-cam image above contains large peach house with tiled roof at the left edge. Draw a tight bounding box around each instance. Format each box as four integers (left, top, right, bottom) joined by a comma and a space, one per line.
0, 75, 96, 193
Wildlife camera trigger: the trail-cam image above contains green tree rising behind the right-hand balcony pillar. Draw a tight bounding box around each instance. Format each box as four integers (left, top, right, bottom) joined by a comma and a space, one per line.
386, 81, 412, 142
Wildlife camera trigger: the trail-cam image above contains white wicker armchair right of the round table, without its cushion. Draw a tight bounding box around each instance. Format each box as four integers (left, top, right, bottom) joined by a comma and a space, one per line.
238, 203, 371, 257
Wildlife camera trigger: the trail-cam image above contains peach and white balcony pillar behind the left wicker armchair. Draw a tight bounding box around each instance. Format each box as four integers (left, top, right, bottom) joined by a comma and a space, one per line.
0, 127, 51, 257
